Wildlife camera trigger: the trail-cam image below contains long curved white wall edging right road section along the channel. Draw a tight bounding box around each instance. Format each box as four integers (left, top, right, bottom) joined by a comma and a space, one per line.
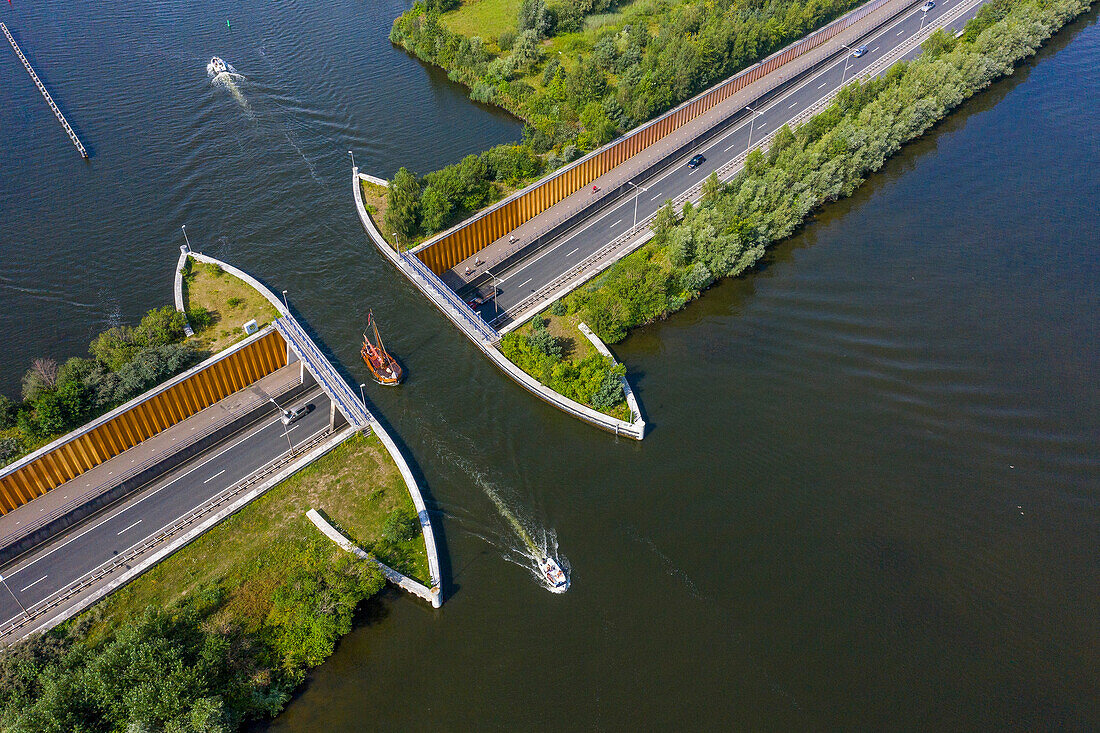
352, 168, 646, 440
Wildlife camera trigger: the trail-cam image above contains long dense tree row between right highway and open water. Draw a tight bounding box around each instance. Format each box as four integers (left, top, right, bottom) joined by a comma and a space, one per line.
567, 0, 1091, 342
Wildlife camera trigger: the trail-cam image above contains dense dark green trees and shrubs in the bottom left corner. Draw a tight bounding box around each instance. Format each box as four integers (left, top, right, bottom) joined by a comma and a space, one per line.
0, 538, 384, 733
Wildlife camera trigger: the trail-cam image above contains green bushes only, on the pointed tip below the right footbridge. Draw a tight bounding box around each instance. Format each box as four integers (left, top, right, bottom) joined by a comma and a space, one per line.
501, 302, 626, 414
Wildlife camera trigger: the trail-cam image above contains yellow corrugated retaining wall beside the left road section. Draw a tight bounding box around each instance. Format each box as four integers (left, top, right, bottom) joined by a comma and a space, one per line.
0, 329, 287, 514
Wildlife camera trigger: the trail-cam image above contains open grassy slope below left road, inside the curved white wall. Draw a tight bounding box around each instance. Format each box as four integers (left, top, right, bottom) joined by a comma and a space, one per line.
92, 435, 431, 636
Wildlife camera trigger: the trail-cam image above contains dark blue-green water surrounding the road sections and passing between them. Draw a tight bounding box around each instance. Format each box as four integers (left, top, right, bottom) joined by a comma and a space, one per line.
0, 0, 1100, 732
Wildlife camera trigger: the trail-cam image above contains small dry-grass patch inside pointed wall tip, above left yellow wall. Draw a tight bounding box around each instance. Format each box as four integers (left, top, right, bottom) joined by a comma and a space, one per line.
184, 258, 278, 353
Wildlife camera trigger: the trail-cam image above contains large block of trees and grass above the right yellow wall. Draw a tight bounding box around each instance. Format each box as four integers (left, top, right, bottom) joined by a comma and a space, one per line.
386, 0, 861, 236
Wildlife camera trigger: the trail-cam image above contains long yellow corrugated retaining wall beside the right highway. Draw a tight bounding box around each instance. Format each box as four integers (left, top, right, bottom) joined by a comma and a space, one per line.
416, 0, 892, 275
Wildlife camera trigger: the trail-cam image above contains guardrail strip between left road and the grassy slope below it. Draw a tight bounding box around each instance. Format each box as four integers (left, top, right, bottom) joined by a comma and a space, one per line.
0, 430, 332, 639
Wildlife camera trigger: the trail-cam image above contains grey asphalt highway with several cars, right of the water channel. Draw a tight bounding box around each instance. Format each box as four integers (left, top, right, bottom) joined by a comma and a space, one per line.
460, 0, 980, 328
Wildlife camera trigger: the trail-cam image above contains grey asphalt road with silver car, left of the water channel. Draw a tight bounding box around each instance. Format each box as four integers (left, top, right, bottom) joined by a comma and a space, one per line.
0, 389, 329, 625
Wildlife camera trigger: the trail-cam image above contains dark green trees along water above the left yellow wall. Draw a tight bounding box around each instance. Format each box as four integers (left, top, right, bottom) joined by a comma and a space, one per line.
0, 306, 210, 466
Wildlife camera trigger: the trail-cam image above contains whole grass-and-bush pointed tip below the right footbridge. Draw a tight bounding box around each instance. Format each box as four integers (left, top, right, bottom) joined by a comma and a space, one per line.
501, 303, 630, 423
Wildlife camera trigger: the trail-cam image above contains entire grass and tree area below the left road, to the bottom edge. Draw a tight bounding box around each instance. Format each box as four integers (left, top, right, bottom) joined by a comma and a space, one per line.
0, 436, 428, 733
